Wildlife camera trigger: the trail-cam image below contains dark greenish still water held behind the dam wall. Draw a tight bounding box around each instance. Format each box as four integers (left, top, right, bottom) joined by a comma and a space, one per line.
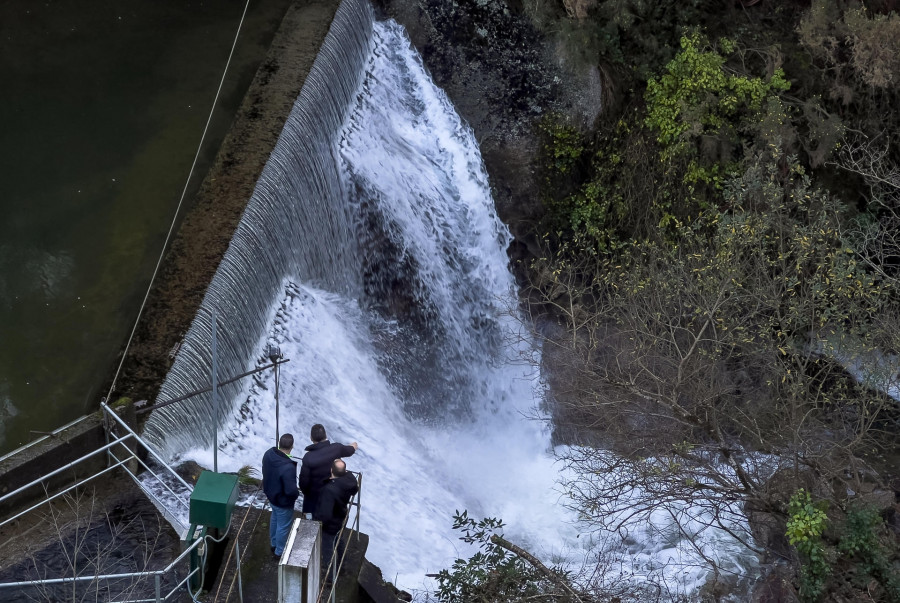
0, 0, 291, 453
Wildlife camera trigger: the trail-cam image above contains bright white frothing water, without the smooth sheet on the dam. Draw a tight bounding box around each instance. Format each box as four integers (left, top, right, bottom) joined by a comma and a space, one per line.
158, 16, 756, 590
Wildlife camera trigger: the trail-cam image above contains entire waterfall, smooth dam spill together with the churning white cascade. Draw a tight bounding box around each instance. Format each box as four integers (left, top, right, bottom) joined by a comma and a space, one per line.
146, 0, 756, 590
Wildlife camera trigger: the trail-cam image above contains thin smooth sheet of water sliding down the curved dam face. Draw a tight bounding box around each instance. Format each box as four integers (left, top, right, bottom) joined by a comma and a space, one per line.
145, 0, 373, 455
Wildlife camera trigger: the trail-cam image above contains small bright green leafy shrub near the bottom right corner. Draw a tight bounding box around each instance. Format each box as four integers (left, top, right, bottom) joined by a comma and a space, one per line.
787, 488, 831, 601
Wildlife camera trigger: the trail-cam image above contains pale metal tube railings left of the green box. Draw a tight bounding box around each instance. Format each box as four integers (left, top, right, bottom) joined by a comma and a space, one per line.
0, 403, 204, 603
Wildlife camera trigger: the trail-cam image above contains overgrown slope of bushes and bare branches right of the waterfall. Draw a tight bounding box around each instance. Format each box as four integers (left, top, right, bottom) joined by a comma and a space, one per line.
436, 0, 900, 601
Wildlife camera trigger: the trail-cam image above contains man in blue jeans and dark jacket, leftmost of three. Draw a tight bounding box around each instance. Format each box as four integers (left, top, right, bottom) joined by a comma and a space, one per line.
263, 433, 300, 557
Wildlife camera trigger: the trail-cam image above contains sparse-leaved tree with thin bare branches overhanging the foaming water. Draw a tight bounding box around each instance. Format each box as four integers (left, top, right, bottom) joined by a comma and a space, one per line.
530, 145, 896, 596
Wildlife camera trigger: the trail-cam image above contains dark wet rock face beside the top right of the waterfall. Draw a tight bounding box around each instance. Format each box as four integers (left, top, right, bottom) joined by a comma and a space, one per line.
382, 0, 562, 238
